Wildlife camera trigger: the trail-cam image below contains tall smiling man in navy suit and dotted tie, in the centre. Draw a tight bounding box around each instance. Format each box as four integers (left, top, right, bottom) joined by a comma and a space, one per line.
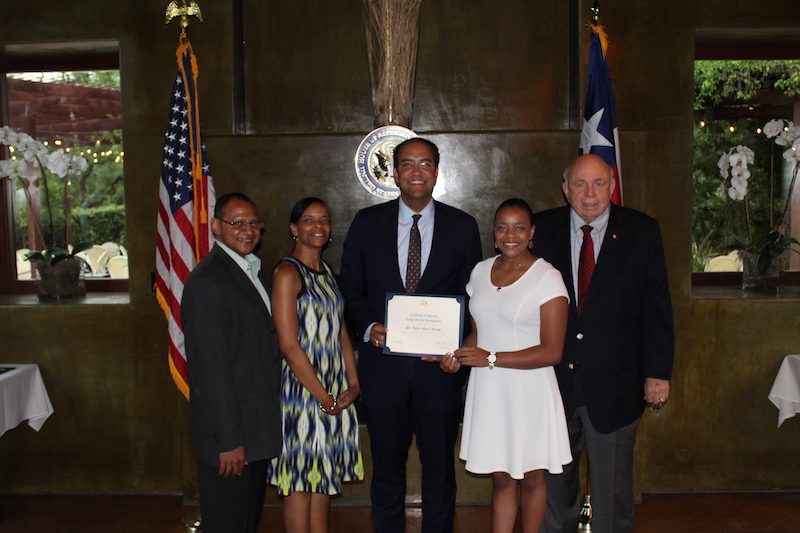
339, 138, 481, 533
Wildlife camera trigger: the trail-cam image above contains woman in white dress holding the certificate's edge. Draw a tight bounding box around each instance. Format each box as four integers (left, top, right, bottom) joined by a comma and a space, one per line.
440, 198, 572, 533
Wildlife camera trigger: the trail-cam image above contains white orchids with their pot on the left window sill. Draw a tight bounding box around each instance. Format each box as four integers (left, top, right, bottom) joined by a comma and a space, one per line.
0, 126, 92, 300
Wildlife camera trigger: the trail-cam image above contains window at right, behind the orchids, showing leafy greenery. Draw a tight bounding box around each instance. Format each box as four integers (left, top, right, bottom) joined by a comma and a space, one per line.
692, 30, 800, 285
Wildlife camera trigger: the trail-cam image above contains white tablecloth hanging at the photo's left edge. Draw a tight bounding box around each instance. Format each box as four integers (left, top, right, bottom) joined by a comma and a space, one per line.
0, 363, 53, 436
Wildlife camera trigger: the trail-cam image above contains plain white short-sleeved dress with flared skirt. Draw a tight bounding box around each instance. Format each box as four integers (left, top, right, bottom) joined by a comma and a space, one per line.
459, 257, 572, 479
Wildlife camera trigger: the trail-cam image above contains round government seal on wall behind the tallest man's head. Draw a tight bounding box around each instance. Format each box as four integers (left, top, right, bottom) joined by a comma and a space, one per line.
355, 126, 417, 200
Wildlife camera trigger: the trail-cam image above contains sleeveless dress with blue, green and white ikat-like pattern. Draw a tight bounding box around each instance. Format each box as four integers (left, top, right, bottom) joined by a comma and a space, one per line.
267, 257, 364, 495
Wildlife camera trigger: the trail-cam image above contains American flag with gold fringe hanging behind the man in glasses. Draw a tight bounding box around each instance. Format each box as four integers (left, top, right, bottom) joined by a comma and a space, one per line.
156, 35, 216, 400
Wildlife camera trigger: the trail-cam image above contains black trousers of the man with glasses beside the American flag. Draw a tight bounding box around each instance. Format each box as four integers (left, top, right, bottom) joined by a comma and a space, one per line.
197, 460, 267, 533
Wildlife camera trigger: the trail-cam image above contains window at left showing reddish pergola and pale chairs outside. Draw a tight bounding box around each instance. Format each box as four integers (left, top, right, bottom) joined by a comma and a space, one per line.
0, 41, 127, 293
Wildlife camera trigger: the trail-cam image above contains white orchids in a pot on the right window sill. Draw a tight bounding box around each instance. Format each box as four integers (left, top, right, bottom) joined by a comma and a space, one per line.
717, 120, 800, 290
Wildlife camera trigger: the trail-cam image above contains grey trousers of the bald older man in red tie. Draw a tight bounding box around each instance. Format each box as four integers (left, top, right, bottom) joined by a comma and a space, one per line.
542, 407, 639, 533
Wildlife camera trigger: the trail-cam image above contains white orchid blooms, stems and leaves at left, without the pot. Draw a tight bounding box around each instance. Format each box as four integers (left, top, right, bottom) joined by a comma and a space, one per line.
0, 126, 92, 266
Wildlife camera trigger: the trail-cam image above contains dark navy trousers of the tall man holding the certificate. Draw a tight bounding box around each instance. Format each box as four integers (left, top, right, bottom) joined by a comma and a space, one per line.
361, 361, 463, 533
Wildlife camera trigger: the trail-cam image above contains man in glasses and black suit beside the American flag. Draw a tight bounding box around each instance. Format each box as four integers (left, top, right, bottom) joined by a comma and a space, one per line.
181, 193, 281, 533
